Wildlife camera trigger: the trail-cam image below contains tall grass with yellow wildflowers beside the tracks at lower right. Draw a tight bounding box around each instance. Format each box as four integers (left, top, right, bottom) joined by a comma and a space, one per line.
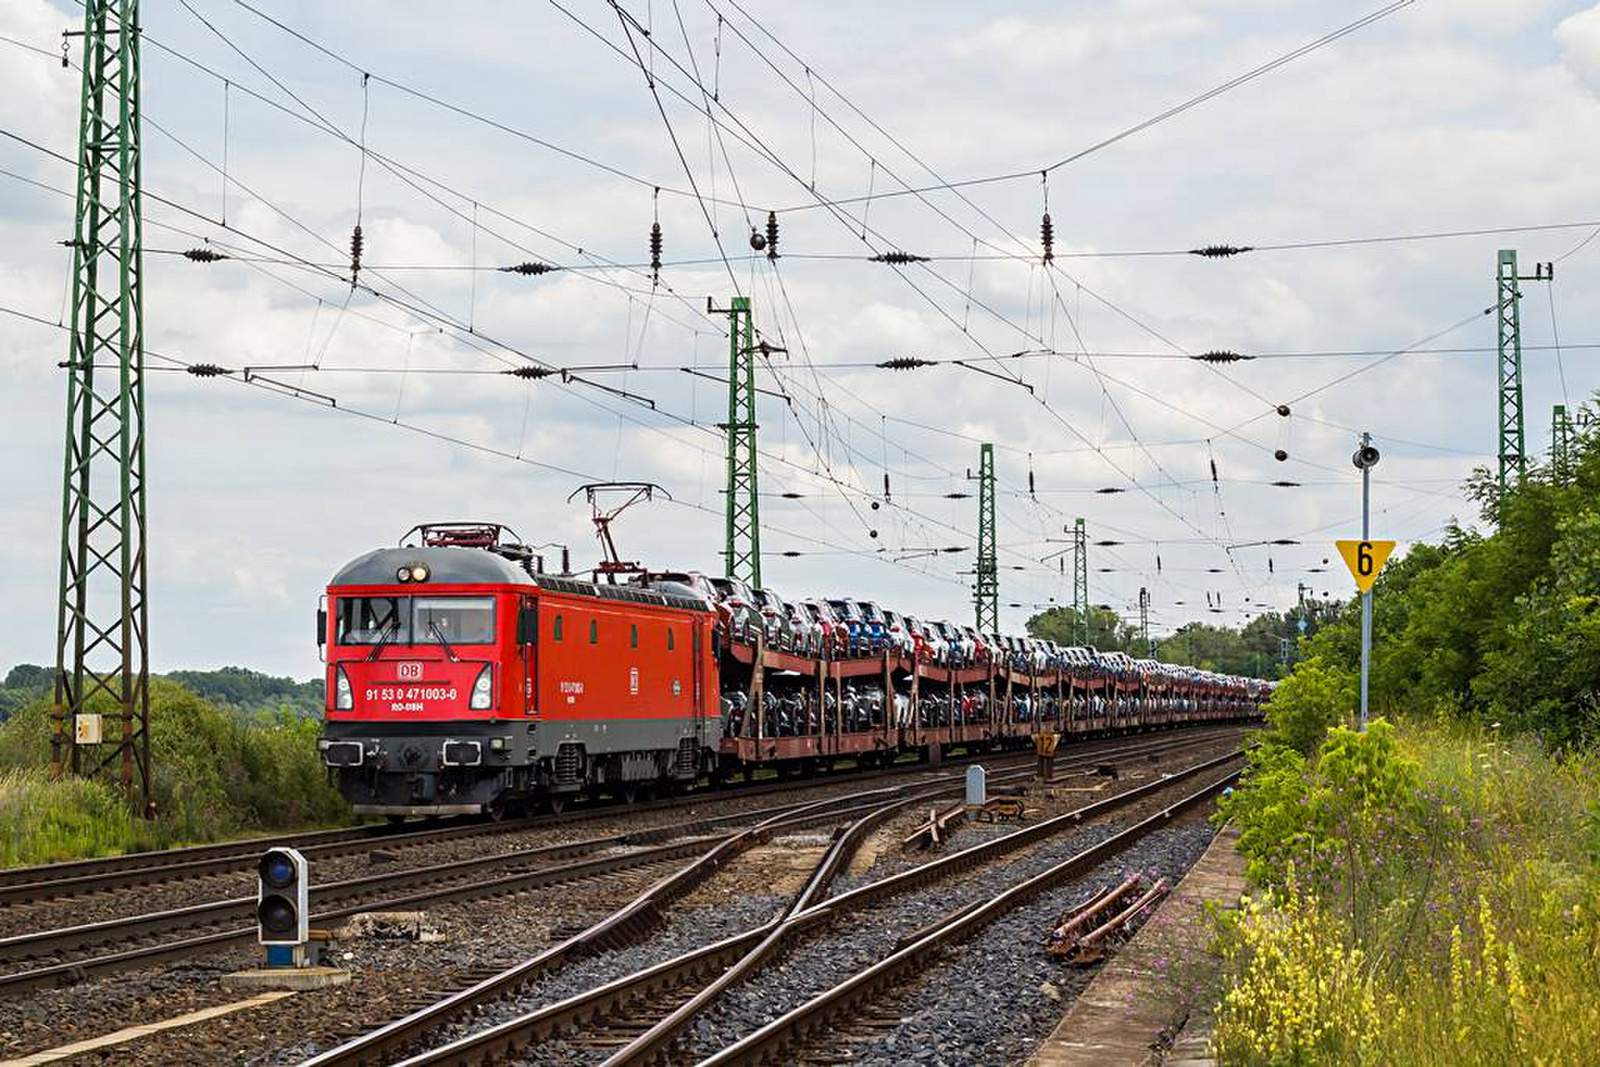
1214, 725, 1600, 1065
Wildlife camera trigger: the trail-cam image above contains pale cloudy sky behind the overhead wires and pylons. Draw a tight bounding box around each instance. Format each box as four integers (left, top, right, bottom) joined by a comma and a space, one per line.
0, 0, 1600, 677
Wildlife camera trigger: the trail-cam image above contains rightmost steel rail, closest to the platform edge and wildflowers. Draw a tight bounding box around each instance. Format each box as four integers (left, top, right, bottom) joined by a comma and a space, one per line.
701, 767, 1240, 1067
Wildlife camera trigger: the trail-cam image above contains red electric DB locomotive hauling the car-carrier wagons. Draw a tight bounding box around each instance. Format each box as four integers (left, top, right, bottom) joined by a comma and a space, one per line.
317, 523, 718, 817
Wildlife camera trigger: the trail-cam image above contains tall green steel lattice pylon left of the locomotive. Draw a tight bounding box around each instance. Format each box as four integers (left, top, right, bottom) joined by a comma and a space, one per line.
50, 0, 150, 814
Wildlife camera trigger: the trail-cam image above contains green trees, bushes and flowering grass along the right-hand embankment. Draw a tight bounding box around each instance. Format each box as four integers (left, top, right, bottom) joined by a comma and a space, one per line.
1213, 412, 1600, 1065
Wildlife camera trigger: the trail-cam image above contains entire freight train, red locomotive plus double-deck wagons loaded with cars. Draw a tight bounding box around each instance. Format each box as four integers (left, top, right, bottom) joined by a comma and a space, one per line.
317, 523, 1270, 819
